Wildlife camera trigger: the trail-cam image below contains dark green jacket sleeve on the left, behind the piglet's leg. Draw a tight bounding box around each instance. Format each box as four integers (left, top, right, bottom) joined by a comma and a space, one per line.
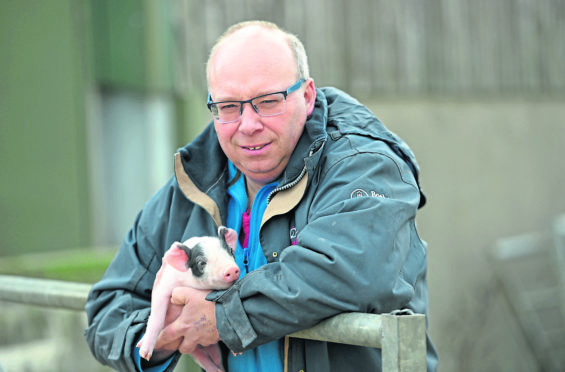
85, 198, 182, 371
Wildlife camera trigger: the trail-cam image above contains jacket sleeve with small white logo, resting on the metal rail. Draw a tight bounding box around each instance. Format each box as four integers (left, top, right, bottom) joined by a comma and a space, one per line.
211, 141, 427, 352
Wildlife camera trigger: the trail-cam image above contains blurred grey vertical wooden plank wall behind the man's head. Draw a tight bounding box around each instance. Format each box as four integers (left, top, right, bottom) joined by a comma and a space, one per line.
170, 0, 565, 96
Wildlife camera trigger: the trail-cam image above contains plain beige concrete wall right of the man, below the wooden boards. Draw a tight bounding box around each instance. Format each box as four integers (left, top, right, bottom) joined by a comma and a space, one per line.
369, 99, 565, 372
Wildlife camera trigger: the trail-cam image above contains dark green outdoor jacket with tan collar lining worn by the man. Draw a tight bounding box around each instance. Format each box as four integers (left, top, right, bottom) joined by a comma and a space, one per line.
85, 88, 437, 372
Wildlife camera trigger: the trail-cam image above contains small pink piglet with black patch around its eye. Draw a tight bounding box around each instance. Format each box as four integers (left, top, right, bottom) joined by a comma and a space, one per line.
137, 226, 240, 372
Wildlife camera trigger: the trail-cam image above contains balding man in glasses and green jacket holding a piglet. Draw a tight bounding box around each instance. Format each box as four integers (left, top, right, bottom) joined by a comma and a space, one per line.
86, 22, 437, 372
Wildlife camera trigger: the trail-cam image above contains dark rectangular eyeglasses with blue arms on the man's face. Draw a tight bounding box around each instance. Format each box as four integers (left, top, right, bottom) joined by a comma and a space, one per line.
207, 79, 306, 124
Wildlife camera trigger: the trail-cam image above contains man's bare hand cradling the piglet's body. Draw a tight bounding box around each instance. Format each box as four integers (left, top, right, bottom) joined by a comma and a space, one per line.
147, 287, 220, 363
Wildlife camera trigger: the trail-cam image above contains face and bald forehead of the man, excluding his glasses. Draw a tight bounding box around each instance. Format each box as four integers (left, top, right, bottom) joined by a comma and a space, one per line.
209, 30, 315, 187
